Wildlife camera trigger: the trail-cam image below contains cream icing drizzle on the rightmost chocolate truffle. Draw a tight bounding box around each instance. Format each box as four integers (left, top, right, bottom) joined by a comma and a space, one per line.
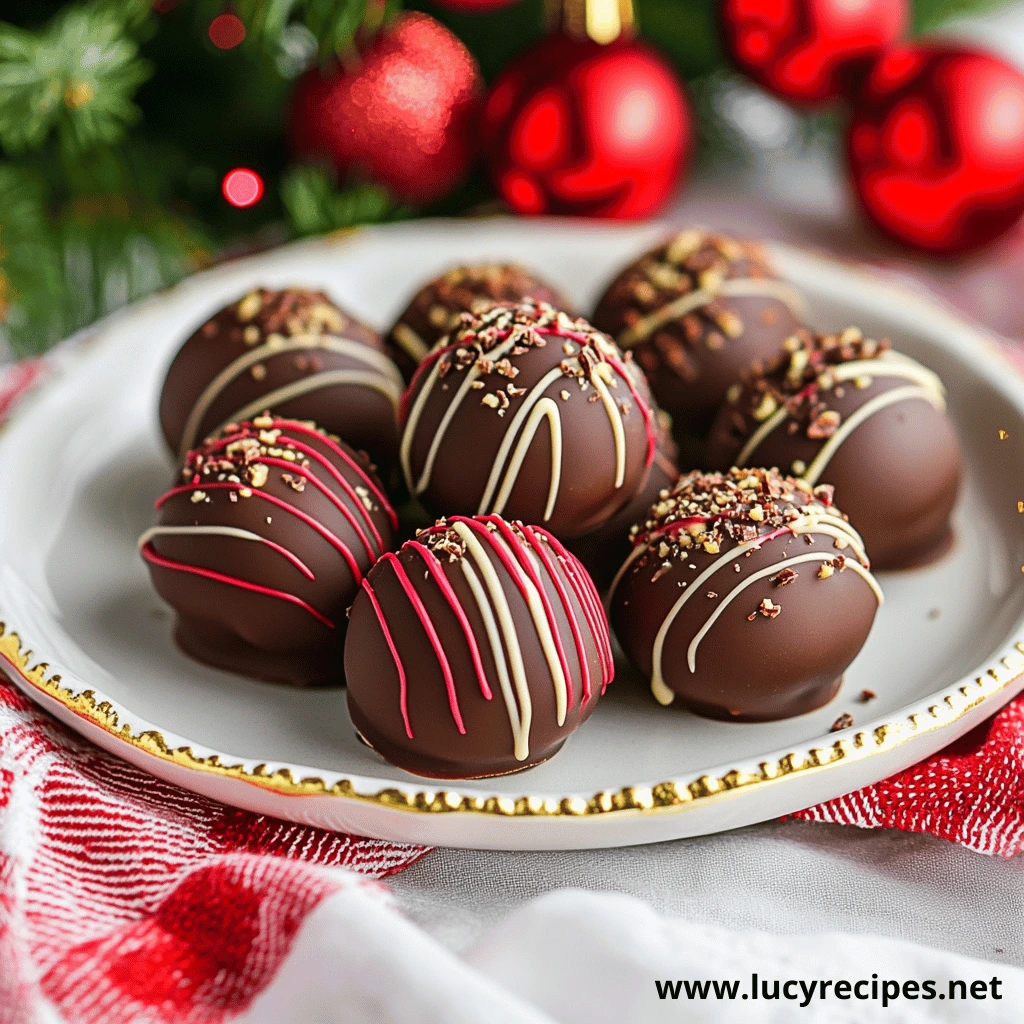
735, 353, 946, 473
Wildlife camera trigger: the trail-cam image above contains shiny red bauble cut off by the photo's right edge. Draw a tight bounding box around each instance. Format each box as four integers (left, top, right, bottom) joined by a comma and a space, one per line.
848, 43, 1024, 254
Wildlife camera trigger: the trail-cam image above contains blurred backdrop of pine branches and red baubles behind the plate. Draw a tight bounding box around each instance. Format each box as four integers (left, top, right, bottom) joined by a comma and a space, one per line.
6, 0, 1024, 360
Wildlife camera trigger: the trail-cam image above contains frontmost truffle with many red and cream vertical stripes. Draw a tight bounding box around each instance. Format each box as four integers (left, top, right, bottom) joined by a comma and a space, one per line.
345, 515, 613, 778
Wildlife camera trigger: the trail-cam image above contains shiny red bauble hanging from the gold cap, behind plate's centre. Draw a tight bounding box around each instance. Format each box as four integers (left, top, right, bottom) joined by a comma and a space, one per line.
483, 34, 692, 218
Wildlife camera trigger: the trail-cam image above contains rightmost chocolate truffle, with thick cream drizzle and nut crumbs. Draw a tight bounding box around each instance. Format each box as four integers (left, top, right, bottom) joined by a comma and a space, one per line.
708, 328, 962, 569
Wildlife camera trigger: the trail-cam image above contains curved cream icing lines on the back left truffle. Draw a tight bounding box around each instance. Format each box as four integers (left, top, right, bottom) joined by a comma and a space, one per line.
179, 335, 402, 457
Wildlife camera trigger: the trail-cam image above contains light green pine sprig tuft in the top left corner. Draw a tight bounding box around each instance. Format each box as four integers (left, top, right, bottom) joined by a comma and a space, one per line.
0, 0, 151, 154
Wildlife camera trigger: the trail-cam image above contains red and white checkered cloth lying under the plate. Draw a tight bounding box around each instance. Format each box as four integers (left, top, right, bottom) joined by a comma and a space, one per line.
0, 348, 1024, 1024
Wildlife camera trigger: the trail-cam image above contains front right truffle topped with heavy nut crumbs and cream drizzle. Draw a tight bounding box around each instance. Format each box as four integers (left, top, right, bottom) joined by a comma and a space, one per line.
611, 469, 882, 722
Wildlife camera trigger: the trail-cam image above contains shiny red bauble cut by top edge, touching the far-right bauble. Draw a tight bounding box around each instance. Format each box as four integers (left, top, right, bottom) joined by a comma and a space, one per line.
722, 0, 910, 105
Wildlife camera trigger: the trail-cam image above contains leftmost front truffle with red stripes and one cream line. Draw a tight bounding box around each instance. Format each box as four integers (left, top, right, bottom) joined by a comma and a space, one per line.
139, 416, 397, 685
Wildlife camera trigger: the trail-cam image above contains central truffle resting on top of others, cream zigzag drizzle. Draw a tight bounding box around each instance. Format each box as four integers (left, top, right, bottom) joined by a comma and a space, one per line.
400, 299, 655, 537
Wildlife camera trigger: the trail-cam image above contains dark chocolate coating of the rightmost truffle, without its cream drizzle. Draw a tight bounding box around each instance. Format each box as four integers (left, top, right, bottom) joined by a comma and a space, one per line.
708, 332, 963, 570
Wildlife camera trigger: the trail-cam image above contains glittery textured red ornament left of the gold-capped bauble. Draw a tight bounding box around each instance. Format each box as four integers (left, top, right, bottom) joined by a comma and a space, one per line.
291, 12, 482, 203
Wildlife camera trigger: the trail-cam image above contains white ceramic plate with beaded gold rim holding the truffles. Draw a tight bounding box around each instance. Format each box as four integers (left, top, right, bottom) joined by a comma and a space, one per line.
0, 219, 1024, 849
